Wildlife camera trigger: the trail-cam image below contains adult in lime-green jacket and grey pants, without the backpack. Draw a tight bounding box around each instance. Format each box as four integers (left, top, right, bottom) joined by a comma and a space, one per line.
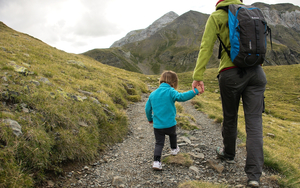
192, 0, 267, 187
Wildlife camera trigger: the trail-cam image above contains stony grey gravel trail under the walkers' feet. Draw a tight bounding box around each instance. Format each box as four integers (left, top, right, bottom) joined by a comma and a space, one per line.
54, 94, 279, 188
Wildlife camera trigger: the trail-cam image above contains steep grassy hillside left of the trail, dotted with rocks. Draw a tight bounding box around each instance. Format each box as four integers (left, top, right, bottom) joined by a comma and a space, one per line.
0, 22, 147, 187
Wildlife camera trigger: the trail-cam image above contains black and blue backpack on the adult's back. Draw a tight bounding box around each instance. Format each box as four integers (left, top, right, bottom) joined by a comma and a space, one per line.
218, 4, 272, 68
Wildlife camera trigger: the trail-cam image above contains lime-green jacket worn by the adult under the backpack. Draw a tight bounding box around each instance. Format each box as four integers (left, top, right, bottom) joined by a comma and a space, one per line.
193, 0, 243, 81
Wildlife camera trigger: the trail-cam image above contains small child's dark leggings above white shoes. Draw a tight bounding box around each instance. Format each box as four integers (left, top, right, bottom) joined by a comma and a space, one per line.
154, 125, 177, 161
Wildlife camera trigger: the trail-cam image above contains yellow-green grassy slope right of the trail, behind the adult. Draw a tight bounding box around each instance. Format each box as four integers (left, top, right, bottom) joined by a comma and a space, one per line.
179, 65, 300, 187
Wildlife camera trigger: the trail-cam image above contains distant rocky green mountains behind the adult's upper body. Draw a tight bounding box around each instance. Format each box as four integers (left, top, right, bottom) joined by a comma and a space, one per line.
83, 3, 300, 74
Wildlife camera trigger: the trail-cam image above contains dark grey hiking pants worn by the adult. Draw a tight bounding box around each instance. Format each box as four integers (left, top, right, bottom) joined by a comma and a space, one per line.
219, 66, 267, 181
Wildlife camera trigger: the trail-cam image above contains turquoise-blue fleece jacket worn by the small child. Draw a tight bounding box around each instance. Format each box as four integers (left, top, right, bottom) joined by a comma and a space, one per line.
145, 83, 199, 129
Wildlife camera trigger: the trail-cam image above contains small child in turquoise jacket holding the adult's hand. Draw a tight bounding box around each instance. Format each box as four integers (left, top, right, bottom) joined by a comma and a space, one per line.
145, 71, 201, 170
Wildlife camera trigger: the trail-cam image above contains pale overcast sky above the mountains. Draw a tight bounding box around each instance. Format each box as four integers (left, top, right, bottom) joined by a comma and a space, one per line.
0, 0, 300, 54
